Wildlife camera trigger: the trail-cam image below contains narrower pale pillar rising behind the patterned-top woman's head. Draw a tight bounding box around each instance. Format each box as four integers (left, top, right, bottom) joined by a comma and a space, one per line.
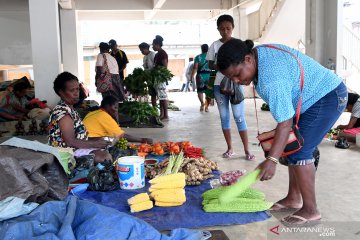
60, 9, 84, 81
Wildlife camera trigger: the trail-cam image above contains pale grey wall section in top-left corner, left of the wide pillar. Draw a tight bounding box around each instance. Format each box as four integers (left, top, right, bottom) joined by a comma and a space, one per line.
0, 0, 32, 65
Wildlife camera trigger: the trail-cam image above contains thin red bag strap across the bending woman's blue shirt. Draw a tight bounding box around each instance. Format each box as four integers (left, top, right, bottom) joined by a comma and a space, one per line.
253, 44, 304, 135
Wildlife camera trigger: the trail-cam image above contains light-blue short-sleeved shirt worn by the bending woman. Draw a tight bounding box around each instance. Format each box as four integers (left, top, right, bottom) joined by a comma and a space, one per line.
256, 44, 342, 122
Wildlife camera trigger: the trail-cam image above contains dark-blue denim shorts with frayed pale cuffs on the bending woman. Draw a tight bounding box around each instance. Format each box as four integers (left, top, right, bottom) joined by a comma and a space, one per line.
288, 83, 347, 165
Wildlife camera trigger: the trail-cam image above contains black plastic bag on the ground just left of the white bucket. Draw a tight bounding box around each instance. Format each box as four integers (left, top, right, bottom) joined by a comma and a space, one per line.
87, 161, 120, 192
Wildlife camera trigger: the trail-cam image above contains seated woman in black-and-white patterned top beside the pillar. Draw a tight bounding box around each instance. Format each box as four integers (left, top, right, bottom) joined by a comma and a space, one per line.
48, 72, 112, 162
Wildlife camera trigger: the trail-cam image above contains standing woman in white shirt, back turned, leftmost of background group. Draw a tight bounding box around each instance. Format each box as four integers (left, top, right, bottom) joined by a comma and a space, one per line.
95, 42, 125, 102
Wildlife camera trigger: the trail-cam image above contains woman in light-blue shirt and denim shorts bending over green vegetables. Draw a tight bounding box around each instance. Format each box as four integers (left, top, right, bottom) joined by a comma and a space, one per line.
217, 39, 347, 226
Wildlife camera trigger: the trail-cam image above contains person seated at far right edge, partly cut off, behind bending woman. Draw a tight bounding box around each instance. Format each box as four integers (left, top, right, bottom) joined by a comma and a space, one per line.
336, 93, 360, 145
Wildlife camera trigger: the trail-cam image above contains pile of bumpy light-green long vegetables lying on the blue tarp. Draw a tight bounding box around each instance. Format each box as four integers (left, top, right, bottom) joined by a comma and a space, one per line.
202, 187, 273, 212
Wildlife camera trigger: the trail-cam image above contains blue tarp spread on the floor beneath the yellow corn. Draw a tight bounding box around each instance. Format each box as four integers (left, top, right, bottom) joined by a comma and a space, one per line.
77, 172, 270, 231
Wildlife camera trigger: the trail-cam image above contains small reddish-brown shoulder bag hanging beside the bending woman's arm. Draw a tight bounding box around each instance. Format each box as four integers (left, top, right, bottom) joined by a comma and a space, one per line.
257, 125, 304, 157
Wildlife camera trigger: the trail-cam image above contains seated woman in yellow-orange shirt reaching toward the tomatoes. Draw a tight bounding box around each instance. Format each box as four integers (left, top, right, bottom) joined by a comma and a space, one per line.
84, 96, 153, 143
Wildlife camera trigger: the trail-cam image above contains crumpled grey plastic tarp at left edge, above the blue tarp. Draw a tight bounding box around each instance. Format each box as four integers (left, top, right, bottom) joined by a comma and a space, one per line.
0, 146, 69, 203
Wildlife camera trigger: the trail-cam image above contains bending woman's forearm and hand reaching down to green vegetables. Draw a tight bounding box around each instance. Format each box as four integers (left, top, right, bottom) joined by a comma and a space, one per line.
257, 118, 293, 181
